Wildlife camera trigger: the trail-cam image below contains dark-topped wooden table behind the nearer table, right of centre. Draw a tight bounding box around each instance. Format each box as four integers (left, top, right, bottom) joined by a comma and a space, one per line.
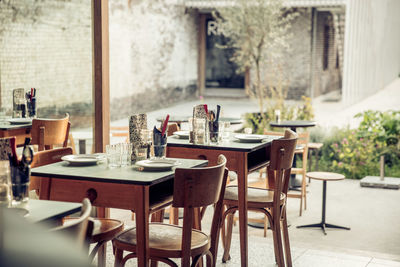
167, 135, 280, 267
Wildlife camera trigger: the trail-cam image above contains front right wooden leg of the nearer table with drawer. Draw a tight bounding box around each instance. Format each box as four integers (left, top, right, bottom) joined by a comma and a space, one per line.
135, 187, 149, 267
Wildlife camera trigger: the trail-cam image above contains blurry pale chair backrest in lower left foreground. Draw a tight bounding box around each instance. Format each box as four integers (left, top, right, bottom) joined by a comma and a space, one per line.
51, 198, 93, 249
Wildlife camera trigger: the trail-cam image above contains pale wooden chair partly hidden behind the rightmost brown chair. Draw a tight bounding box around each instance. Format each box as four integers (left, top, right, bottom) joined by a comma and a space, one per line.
288, 132, 310, 216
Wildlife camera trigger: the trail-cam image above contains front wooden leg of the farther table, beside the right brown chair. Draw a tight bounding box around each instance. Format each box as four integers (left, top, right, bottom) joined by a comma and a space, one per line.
237, 153, 248, 267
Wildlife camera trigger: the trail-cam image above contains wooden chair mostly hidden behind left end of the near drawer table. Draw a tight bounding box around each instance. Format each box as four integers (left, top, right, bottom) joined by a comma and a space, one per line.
30, 147, 124, 266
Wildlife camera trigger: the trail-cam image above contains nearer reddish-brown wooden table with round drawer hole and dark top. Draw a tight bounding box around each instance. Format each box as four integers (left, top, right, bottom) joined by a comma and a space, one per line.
31, 159, 208, 266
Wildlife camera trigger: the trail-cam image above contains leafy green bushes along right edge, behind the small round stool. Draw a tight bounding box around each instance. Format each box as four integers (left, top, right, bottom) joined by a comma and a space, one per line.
320, 110, 400, 179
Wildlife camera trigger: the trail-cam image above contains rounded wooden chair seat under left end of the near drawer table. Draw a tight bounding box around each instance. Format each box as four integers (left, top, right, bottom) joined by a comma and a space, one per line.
63, 218, 124, 243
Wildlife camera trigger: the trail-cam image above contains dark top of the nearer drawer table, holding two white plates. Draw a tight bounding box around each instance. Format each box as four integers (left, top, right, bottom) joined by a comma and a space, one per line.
31, 159, 208, 185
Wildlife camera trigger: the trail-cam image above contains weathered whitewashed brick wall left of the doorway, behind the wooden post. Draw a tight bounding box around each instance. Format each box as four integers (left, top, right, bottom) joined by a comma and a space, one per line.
0, 0, 197, 123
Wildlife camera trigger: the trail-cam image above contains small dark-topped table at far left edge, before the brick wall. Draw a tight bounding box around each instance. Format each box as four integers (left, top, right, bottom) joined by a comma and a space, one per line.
0, 120, 32, 146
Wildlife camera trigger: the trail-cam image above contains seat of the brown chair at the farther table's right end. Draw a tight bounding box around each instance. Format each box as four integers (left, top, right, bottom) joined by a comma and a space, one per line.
224, 186, 285, 206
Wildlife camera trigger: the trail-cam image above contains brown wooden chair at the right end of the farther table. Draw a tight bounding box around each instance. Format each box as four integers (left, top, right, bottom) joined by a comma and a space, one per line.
222, 130, 297, 267
